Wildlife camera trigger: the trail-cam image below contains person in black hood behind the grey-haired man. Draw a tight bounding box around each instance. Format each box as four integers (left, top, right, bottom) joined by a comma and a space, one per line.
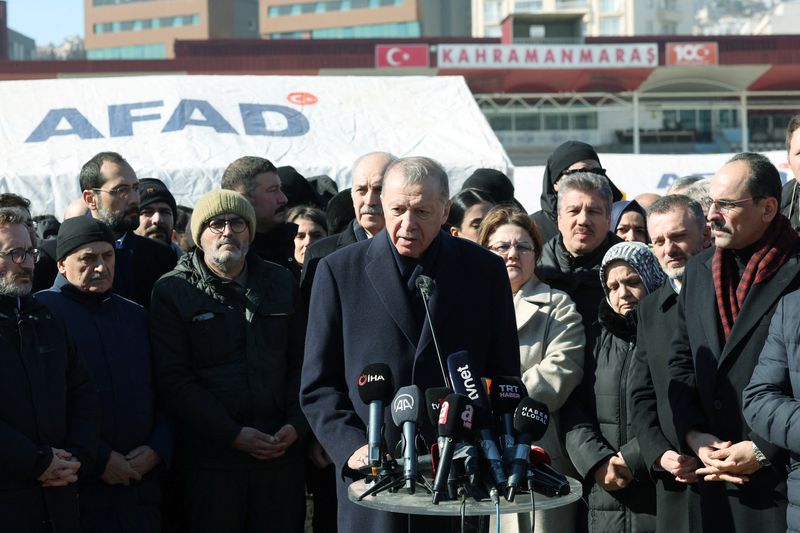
531, 141, 622, 242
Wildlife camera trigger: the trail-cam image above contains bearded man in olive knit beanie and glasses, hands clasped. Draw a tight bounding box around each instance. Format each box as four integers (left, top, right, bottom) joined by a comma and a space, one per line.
150, 190, 307, 533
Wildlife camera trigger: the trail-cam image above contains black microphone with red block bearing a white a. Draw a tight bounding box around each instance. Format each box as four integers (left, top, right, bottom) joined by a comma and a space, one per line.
433, 394, 475, 505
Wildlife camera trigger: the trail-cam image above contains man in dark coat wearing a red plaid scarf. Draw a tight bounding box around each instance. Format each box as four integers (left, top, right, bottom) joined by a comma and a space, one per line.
669, 153, 800, 533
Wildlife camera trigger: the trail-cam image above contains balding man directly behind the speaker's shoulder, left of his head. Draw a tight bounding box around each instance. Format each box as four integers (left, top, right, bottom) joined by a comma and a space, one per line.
300, 152, 397, 304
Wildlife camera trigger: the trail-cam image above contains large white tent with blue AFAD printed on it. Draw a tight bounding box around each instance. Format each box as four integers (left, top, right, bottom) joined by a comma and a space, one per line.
0, 76, 513, 218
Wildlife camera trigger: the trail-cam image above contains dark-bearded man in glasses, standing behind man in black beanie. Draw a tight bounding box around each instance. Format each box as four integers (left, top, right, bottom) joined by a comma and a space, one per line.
80, 152, 177, 307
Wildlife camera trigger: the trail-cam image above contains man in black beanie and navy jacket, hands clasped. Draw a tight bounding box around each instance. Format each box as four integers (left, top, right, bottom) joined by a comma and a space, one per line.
36, 217, 172, 533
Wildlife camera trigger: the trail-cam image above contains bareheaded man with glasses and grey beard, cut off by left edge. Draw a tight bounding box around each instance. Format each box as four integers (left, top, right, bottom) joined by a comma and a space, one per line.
0, 208, 100, 533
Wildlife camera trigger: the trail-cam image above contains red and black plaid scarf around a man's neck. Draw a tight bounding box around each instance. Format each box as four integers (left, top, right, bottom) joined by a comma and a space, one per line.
711, 214, 800, 342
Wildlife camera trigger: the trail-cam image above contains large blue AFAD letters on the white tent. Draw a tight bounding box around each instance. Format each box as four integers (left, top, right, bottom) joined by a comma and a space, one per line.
25, 100, 310, 143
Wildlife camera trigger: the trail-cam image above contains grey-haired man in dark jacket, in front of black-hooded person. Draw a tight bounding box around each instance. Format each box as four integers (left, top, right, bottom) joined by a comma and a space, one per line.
536, 171, 621, 355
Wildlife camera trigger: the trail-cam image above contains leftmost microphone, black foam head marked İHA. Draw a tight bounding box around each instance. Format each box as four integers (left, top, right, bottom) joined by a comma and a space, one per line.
358, 363, 394, 475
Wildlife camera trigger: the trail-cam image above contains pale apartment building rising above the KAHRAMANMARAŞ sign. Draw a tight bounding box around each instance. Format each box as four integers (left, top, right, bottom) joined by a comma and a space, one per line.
472, 0, 694, 38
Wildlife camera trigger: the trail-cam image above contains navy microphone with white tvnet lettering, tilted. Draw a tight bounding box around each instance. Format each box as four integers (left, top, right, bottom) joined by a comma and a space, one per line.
447, 350, 508, 490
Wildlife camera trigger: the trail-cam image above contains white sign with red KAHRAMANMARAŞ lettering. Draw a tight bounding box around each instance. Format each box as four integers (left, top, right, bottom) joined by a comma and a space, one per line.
437, 43, 658, 69
